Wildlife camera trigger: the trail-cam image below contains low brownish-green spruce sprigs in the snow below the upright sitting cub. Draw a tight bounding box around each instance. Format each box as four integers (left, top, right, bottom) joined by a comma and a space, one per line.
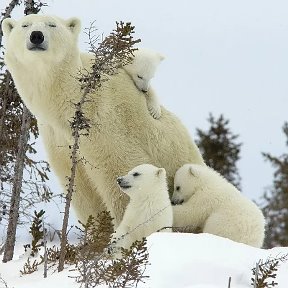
77, 212, 148, 288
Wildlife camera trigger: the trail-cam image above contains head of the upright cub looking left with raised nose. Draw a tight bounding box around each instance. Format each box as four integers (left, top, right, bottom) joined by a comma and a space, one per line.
117, 164, 166, 197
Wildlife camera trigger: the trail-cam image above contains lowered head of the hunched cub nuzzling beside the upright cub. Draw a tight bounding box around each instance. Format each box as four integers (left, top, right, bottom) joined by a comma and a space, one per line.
171, 164, 201, 205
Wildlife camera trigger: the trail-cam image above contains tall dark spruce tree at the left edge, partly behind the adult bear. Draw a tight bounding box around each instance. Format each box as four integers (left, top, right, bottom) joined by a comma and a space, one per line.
0, 0, 51, 262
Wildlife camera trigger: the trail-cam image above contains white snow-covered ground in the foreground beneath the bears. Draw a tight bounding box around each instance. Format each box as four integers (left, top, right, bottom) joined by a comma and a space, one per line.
0, 233, 288, 288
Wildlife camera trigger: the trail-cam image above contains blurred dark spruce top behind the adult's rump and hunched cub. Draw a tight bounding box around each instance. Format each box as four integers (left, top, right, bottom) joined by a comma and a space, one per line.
196, 113, 242, 188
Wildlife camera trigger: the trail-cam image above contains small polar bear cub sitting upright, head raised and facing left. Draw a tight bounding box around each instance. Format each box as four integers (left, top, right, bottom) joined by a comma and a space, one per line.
113, 164, 173, 253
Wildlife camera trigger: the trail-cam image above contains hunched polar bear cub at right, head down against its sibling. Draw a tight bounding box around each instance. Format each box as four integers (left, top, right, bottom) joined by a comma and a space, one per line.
171, 164, 265, 247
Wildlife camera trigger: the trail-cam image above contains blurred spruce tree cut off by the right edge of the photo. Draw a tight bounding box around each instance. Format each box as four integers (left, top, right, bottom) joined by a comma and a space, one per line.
262, 122, 288, 248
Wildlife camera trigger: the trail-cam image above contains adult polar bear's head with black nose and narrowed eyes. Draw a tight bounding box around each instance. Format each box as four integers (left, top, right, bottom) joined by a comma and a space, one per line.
2, 15, 80, 66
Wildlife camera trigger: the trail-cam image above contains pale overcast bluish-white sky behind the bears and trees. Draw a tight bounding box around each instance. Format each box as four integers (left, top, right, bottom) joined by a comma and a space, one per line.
0, 0, 288, 199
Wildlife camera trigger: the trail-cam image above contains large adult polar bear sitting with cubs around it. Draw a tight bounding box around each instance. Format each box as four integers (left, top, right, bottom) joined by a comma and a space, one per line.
2, 15, 203, 225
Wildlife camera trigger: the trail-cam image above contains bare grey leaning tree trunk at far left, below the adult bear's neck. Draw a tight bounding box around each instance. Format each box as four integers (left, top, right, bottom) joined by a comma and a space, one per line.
3, 105, 31, 262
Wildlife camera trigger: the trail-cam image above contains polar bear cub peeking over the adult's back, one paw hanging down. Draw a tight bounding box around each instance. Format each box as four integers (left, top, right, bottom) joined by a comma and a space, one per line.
123, 48, 164, 119
